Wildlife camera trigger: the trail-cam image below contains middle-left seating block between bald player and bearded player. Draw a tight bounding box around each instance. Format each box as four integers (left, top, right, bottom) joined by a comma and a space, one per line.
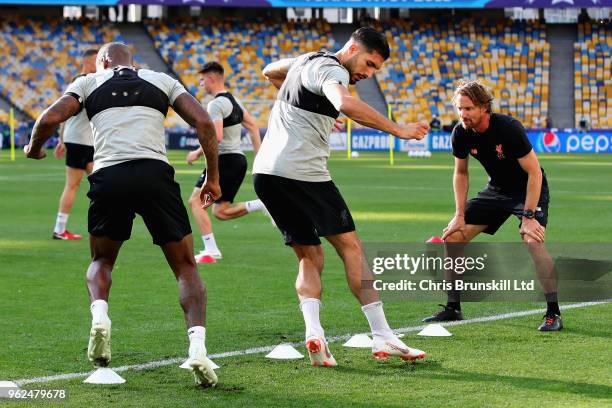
146, 18, 336, 128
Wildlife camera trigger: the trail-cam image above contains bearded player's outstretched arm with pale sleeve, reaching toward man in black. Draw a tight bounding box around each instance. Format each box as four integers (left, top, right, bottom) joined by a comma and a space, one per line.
323, 83, 429, 140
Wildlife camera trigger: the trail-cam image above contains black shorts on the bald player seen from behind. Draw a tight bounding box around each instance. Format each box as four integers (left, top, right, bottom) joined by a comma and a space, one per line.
87, 159, 191, 246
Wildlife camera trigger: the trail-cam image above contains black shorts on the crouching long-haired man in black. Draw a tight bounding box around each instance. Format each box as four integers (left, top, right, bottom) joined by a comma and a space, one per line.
465, 185, 550, 235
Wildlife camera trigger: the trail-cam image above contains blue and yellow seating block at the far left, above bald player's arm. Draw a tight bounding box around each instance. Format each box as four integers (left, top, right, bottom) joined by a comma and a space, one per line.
0, 17, 136, 118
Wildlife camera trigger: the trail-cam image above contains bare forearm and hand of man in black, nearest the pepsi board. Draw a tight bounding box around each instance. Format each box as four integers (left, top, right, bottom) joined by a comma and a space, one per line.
518, 149, 544, 242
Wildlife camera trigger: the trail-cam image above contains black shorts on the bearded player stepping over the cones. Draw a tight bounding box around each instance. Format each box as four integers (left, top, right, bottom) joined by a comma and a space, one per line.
253, 174, 355, 245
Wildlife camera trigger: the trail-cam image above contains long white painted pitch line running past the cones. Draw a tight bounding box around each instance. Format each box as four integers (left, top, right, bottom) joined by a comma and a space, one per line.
14, 299, 612, 387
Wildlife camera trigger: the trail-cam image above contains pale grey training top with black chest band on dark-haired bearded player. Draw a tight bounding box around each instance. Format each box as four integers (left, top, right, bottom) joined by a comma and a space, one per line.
253, 53, 349, 182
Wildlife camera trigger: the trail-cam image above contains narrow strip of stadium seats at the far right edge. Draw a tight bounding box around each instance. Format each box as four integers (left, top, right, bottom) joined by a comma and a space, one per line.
574, 22, 612, 129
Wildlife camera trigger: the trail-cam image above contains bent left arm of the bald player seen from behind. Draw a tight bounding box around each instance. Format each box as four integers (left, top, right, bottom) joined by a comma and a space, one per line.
23, 95, 81, 160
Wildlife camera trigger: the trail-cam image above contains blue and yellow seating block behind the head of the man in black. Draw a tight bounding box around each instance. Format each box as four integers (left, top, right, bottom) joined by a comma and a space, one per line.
378, 19, 549, 127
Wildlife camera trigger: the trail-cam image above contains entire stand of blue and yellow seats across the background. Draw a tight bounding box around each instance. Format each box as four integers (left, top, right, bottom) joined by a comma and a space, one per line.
0, 16, 612, 135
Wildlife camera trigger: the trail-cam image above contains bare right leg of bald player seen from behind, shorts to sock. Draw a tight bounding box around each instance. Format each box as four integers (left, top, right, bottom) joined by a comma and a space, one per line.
162, 234, 206, 328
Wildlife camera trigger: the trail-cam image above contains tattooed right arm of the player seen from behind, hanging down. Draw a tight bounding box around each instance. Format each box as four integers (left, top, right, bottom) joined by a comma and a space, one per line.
173, 92, 221, 207
